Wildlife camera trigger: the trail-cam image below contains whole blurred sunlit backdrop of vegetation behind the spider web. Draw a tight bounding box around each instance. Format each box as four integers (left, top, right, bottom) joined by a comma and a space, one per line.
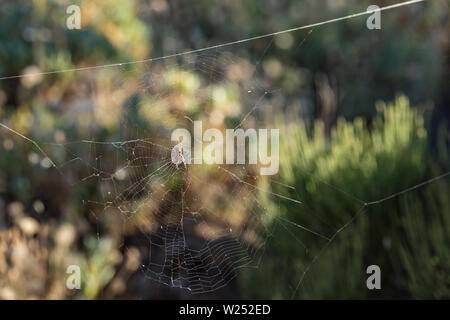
0, 0, 450, 299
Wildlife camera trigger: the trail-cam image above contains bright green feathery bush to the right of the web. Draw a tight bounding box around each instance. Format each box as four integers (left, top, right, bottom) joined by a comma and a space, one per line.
243, 96, 450, 299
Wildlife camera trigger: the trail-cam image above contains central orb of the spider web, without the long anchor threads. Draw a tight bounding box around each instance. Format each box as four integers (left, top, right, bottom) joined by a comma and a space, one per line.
46, 48, 284, 293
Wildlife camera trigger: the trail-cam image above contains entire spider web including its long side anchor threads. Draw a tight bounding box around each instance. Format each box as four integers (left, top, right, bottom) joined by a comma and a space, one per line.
1, 0, 449, 296
